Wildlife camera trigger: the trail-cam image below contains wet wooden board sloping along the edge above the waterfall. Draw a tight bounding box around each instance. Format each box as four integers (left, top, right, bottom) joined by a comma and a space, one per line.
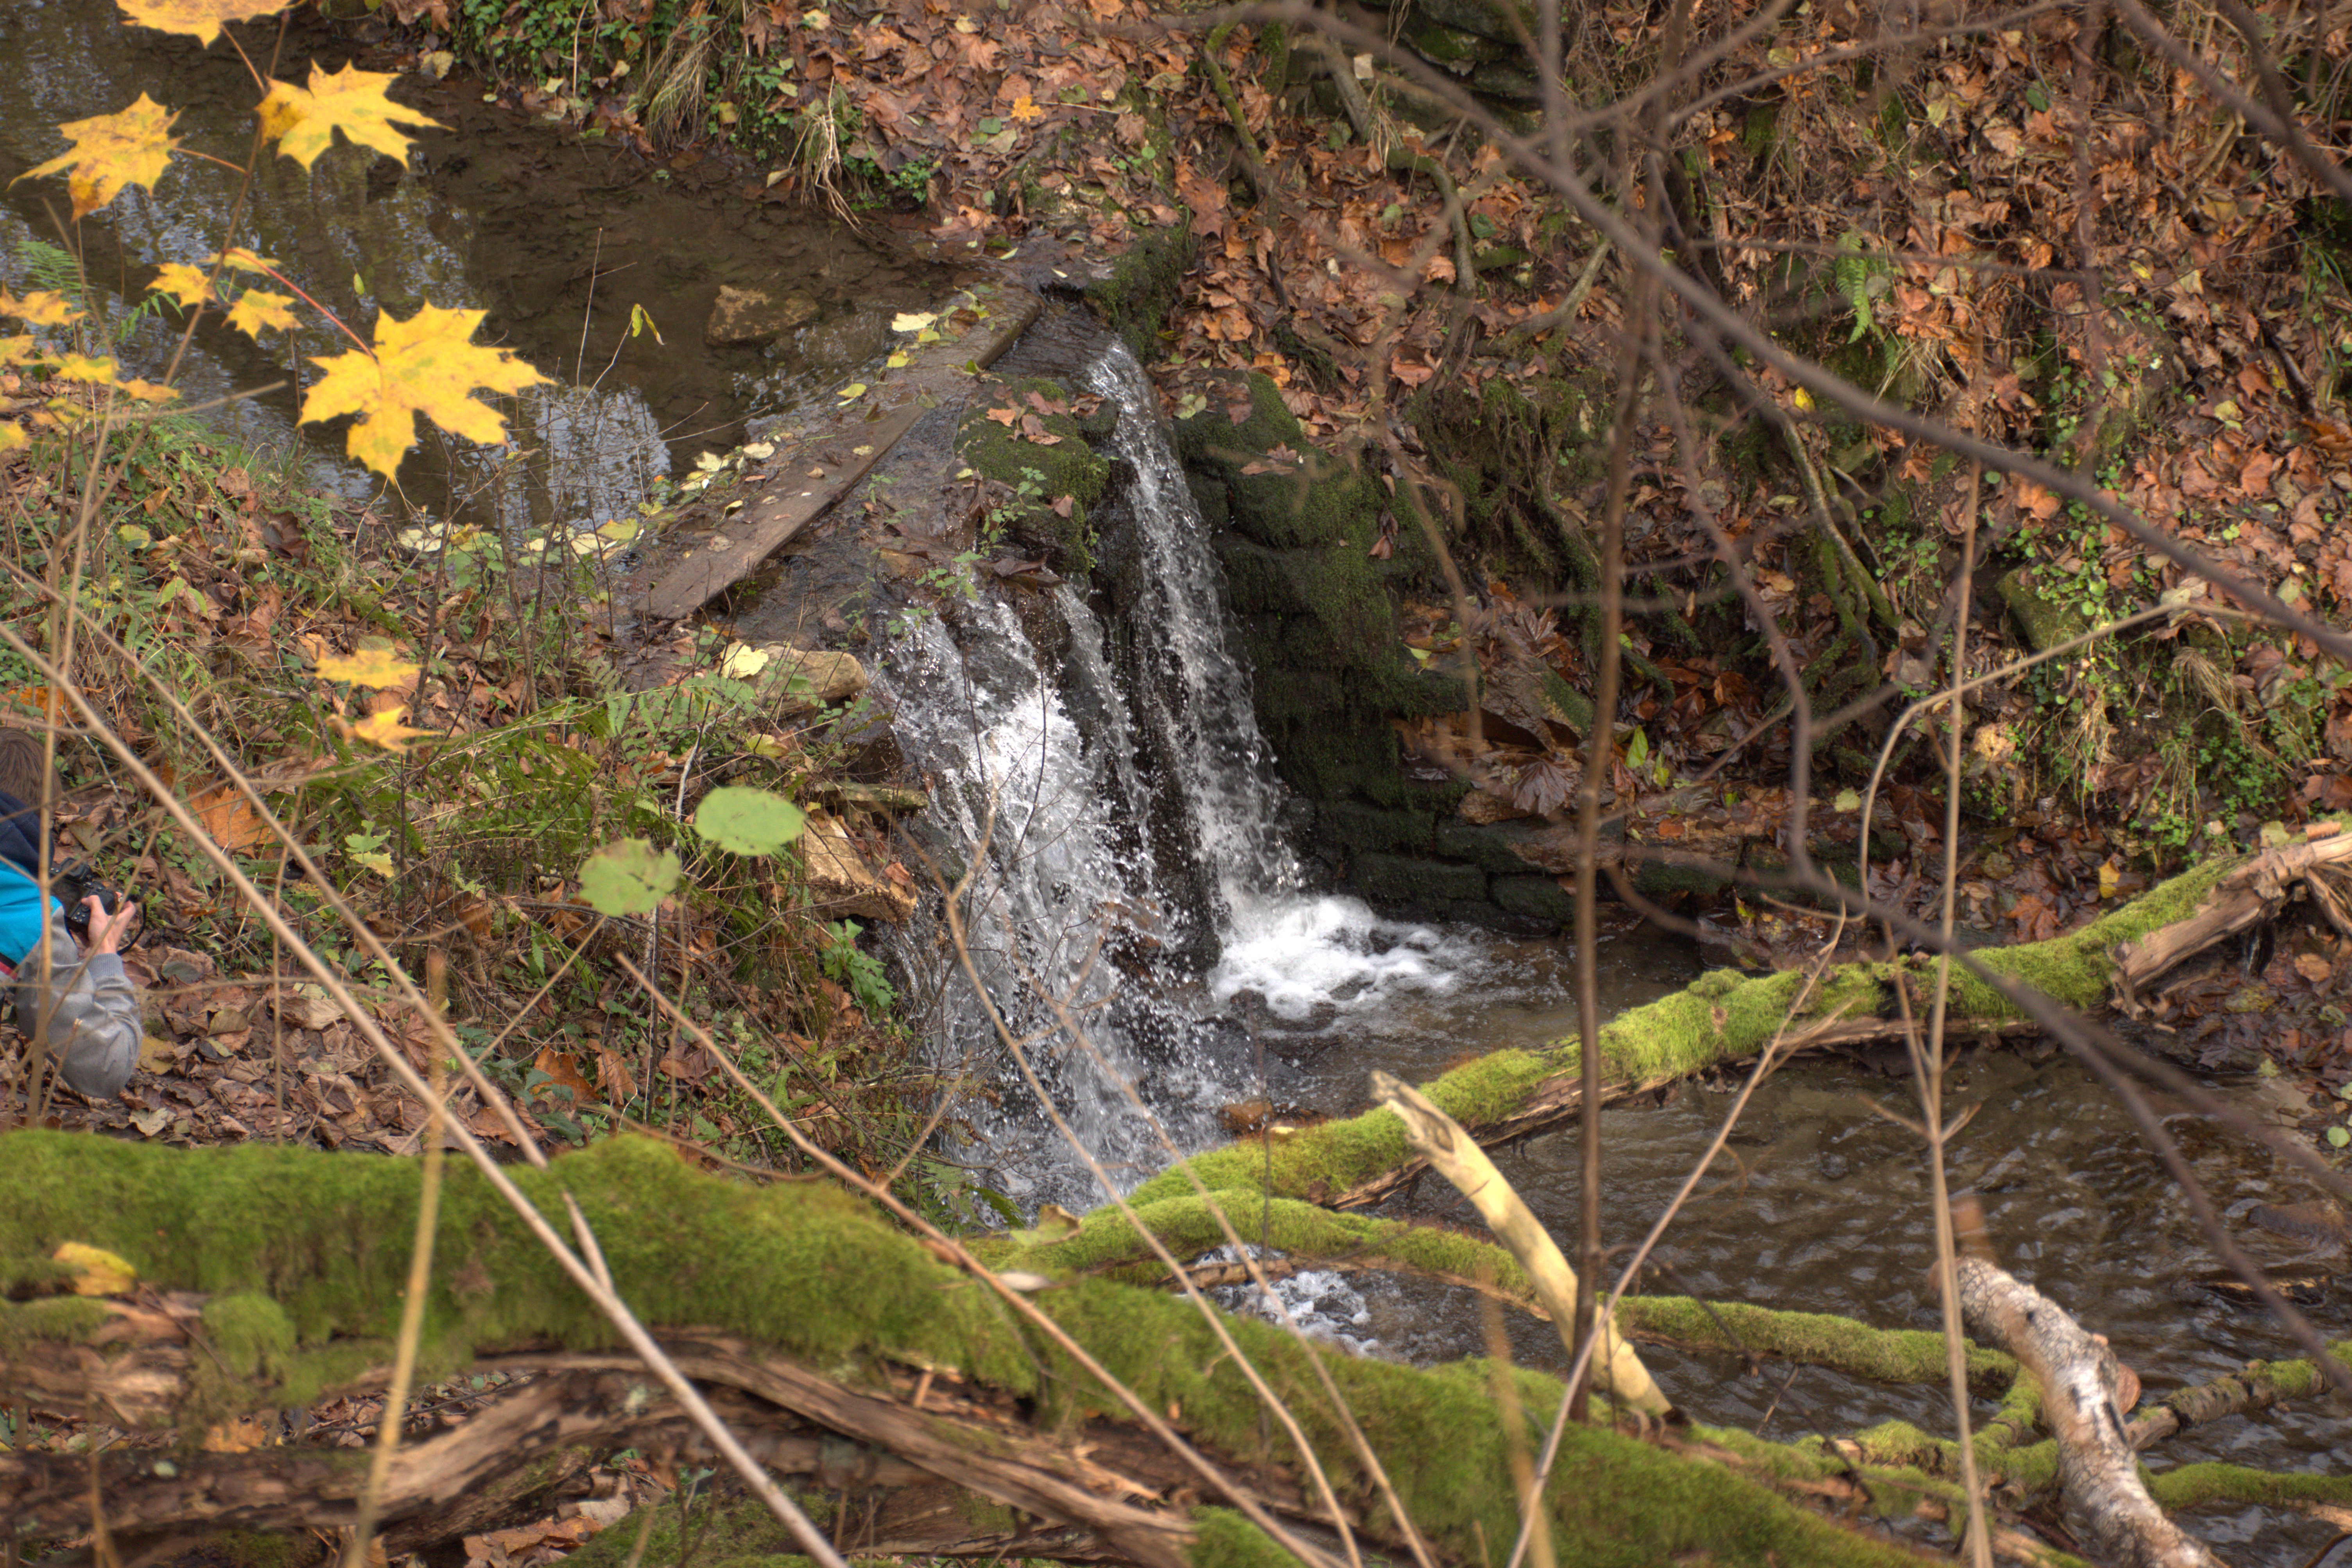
644, 287, 1042, 621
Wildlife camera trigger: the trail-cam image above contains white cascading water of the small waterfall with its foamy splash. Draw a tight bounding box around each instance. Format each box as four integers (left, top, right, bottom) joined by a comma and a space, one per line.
877, 324, 1468, 1208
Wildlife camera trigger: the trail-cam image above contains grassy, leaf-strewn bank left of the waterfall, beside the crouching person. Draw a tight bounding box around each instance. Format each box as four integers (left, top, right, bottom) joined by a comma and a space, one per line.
0, 390, 962, 1215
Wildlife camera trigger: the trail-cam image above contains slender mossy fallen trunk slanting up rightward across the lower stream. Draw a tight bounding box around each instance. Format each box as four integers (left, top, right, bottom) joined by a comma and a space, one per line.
1134, 846, 2267, 1208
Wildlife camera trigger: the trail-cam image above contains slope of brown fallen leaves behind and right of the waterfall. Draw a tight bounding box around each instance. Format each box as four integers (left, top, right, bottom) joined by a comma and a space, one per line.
398, 0, 2352, 1091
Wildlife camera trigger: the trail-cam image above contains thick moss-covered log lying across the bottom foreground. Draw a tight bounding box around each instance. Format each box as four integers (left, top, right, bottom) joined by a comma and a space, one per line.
0, 1131, 1947, 1568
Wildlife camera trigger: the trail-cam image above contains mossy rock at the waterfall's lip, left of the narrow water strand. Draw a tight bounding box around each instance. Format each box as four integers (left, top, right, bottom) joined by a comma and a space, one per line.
955, 376, 1117, 573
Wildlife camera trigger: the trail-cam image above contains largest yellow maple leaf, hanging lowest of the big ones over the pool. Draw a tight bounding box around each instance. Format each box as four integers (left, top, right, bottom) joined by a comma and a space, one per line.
301, 306, 546, 477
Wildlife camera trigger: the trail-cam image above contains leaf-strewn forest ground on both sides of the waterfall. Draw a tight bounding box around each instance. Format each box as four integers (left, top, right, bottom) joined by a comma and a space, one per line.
0, 0, 2352, 1568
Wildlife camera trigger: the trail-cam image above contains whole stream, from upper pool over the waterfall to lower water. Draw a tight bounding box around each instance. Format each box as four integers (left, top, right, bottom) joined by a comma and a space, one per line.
0, 0, 2352, 1566
